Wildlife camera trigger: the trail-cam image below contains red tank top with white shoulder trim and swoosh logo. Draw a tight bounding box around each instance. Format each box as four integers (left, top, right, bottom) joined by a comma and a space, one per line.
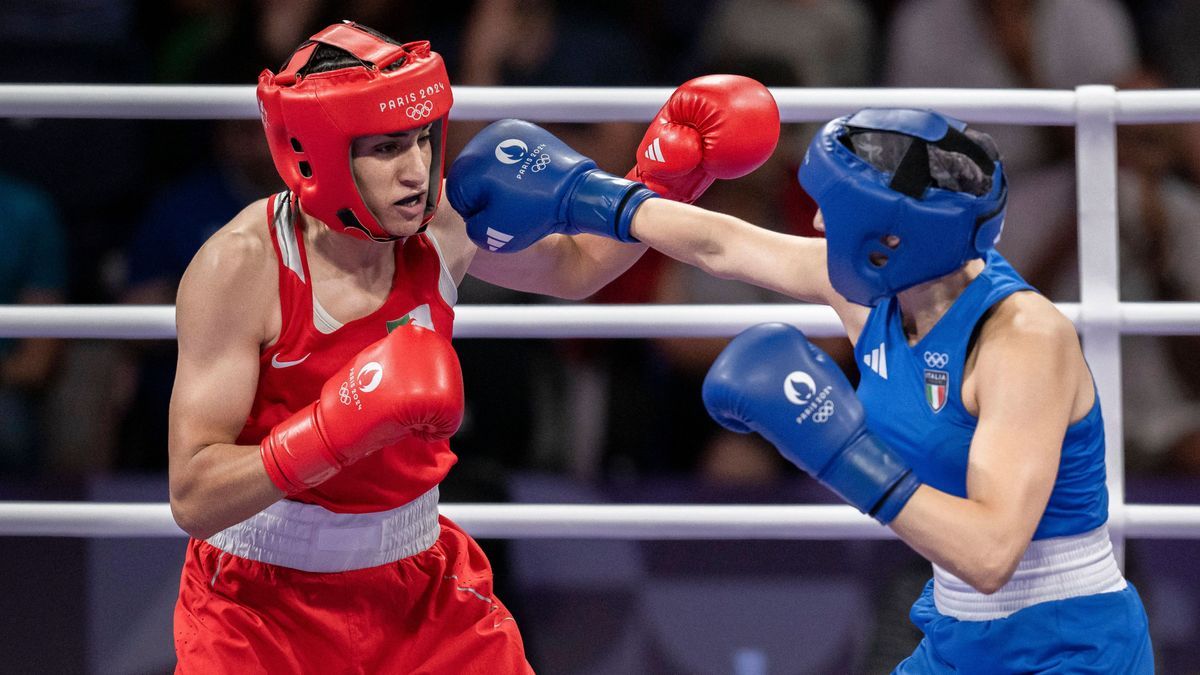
238, 192, 457, 513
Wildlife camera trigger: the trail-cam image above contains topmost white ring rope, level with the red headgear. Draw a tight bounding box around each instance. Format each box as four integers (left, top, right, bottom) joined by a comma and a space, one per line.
7, 84, 1200, 126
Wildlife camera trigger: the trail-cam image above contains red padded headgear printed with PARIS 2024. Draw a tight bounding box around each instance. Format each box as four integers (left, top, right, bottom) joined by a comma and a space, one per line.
258, 22, 454, 241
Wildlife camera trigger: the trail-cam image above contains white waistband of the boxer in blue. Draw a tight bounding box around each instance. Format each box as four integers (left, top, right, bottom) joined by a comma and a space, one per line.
934, 525, 1126, 621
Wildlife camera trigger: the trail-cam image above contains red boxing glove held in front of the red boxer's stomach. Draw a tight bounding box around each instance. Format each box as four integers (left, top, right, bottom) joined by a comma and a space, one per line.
259, 324, 463, 495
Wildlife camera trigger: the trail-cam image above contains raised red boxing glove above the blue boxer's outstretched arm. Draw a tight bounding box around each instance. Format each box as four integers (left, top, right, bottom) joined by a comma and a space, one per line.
625, 74, 779, 204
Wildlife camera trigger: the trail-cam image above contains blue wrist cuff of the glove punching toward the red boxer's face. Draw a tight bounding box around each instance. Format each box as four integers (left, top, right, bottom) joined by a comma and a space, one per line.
566, 171, 658, 243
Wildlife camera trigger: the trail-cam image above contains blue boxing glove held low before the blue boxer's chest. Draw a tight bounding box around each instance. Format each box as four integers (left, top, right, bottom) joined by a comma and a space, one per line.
703, 323, 920, 525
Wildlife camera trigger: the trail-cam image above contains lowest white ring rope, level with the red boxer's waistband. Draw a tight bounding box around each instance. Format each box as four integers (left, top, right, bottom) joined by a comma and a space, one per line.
0, 502, 1200, 539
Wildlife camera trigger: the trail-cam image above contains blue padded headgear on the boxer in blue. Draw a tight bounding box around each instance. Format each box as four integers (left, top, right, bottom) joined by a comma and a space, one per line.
799, 108, 1008, 306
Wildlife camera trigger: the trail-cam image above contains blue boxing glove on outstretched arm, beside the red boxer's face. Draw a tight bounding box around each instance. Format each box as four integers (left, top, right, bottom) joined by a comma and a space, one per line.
446, 120, 658, 253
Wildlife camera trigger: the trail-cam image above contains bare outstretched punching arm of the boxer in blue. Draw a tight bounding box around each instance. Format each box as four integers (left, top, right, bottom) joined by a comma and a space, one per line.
630, 199, 869, 342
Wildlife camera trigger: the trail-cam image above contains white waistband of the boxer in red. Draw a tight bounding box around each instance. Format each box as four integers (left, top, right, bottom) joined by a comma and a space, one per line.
208, 486, 440, 572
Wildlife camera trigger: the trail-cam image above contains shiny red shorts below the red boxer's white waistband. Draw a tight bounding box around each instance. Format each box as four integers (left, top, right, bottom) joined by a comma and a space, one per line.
175, 518, 533, 675
